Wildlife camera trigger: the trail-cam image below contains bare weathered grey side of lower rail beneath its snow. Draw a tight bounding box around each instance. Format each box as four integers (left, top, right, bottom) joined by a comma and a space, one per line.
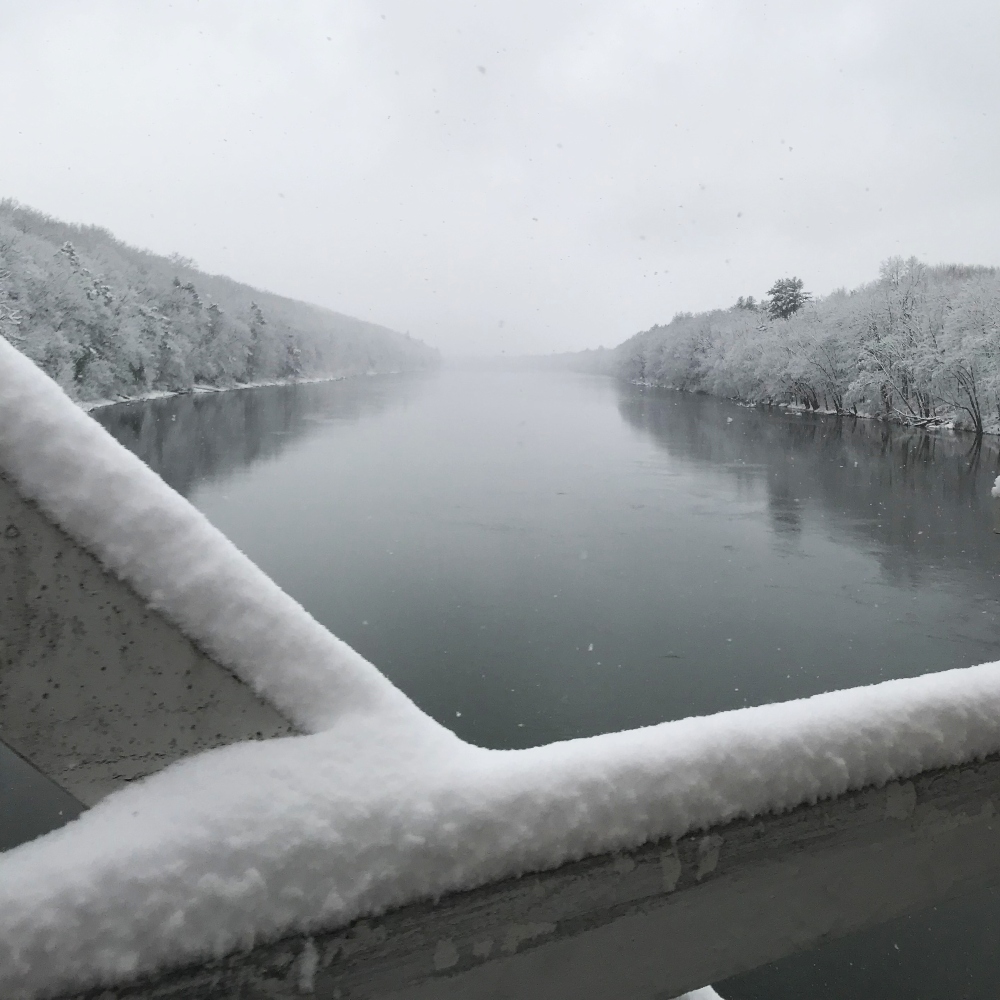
58, 758, 1000, 1000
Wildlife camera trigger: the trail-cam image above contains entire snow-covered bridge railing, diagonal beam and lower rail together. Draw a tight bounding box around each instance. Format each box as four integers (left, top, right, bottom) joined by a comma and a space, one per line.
0, 341, 1000, 1000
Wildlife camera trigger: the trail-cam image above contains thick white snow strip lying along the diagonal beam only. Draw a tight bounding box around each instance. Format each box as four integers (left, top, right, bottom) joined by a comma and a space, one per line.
0, 337, 426, 731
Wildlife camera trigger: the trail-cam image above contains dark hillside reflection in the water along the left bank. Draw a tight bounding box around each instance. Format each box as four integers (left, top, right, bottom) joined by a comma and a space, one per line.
93, 374, 429, 495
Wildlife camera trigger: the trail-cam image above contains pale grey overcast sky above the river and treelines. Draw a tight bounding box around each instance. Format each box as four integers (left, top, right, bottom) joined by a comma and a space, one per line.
0, 0, 1000, 354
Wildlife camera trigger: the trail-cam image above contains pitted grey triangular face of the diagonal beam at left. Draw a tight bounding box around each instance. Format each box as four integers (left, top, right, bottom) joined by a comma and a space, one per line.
0, 476, 294, 805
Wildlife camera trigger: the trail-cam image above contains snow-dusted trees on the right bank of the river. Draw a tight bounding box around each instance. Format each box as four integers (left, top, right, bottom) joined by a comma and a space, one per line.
616, 257, 1000, 433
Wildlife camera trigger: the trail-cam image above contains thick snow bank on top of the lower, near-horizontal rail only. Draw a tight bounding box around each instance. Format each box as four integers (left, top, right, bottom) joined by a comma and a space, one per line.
7, 665, 1000, 1000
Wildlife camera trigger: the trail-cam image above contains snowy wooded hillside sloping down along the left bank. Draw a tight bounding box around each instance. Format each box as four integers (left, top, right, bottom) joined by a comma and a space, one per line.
0, 200, 439, 401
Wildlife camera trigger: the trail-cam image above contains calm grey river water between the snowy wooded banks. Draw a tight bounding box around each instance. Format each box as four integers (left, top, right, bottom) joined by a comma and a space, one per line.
5, 371, 1000, 1000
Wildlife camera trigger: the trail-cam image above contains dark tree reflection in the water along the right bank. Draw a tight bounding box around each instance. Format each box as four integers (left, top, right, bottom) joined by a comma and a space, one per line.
618, 384, 1000, 582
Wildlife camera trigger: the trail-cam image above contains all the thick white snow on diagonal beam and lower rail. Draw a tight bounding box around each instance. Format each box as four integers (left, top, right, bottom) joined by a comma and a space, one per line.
0, 340, 1000, 998
